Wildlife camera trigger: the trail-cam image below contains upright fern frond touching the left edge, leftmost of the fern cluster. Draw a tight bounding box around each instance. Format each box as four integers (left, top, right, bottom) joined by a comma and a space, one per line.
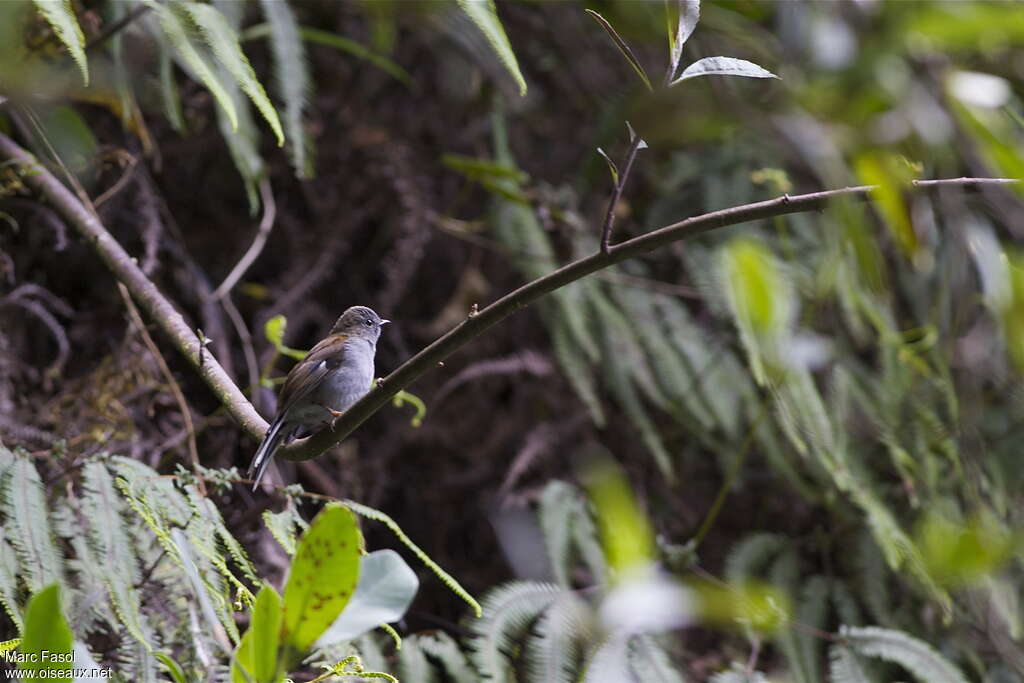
0, 456, 63, 593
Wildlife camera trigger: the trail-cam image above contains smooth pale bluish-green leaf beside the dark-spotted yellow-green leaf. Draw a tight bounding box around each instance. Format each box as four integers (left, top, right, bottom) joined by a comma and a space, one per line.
317, 550, 420, 646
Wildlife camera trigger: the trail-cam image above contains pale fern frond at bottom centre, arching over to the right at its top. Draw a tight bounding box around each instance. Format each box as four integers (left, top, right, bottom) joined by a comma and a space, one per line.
471, 582, 565, 681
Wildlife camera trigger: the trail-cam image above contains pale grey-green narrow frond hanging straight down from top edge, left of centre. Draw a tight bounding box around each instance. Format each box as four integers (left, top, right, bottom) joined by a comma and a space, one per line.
260, 0, 312, 178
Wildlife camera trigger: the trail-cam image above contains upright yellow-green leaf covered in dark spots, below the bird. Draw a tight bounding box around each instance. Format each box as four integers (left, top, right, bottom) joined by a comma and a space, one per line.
283, 504, 362, 668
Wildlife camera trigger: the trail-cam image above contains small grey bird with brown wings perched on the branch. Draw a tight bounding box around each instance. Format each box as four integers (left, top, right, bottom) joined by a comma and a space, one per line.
249, 306, 390, 490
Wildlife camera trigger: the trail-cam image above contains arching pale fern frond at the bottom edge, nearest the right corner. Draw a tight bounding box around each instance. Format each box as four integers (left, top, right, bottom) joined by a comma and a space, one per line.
840, 626, 967, 683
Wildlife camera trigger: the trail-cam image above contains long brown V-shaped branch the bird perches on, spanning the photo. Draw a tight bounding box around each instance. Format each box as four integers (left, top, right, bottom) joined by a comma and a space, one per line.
0, 134, 1021, 461
